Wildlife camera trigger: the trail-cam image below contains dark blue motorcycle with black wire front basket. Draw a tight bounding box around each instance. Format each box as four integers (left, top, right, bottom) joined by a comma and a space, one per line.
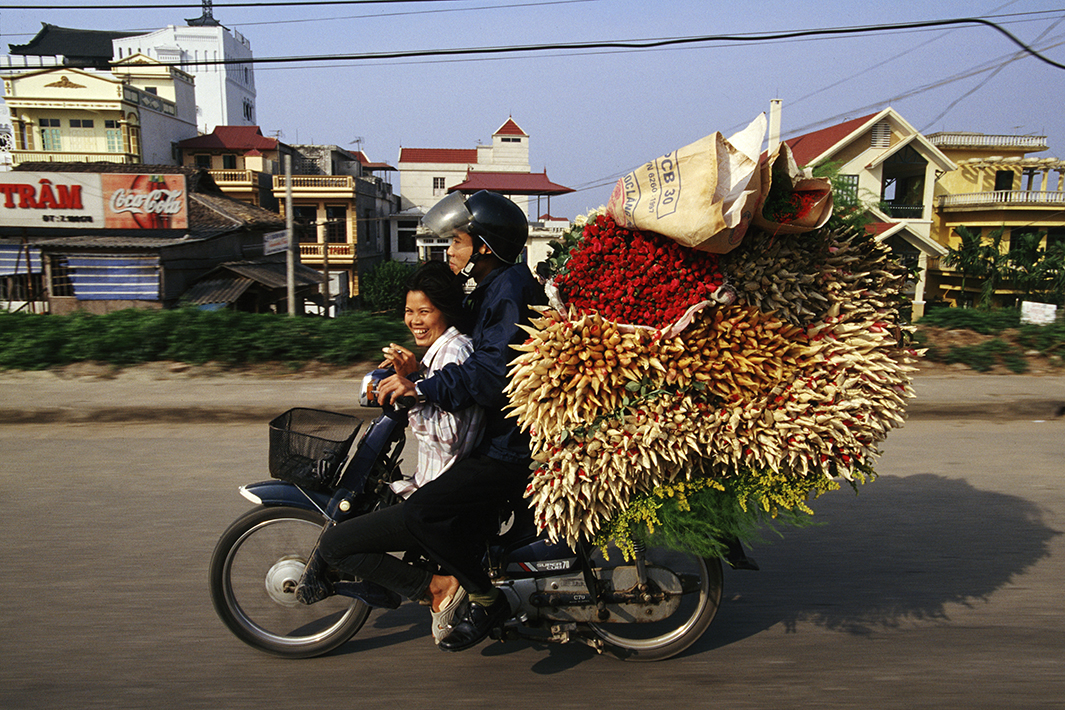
210, 370, 736, 661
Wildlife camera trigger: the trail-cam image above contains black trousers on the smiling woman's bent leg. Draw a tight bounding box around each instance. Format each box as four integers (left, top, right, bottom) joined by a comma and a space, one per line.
318, 502, 432, 601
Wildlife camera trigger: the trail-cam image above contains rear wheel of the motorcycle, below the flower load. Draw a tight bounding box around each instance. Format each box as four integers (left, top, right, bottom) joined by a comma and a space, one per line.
589, 547, 723, 661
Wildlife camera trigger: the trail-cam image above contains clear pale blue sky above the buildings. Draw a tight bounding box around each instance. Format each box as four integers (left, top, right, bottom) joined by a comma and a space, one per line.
0, 0, 1065, 218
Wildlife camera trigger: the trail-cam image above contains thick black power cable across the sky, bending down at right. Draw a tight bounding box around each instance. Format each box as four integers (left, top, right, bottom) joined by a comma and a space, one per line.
116, 16, 1065, 69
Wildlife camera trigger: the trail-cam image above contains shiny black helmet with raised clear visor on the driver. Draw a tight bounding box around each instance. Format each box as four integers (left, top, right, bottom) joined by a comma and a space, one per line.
422, 189, 529, 264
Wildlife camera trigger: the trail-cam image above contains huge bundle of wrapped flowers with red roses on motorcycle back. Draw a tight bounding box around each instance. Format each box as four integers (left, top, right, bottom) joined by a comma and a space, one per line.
507, 214, 913, 556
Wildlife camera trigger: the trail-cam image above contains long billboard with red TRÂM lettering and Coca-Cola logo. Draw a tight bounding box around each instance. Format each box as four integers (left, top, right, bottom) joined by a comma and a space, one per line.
0, 171, 189, 229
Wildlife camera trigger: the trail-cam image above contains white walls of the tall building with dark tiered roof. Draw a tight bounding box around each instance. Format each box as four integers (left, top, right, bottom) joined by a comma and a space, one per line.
112, 24, 256, 133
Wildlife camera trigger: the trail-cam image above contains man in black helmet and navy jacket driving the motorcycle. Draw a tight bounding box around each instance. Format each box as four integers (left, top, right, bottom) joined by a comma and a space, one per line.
379, 191, 546, 650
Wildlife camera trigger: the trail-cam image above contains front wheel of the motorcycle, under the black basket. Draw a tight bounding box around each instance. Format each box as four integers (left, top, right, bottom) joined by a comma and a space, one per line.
210, 506, 370, 658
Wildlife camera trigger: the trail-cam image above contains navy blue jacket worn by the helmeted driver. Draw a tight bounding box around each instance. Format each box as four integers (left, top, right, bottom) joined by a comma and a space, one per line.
419, 264, 547, 463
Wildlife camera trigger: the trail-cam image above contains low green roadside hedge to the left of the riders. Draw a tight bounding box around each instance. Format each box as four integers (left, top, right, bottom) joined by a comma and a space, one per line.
0, 309, 409, 369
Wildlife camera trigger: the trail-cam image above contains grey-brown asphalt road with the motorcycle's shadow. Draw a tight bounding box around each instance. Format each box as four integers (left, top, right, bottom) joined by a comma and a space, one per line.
0, 420, 1065, 710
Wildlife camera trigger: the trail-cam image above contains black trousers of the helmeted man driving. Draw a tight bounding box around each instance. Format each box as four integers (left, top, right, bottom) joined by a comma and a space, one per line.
403, 456, 531, 594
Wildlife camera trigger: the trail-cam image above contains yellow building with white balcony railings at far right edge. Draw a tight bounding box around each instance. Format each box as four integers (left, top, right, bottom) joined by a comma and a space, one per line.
928, 133, 1065, 306
